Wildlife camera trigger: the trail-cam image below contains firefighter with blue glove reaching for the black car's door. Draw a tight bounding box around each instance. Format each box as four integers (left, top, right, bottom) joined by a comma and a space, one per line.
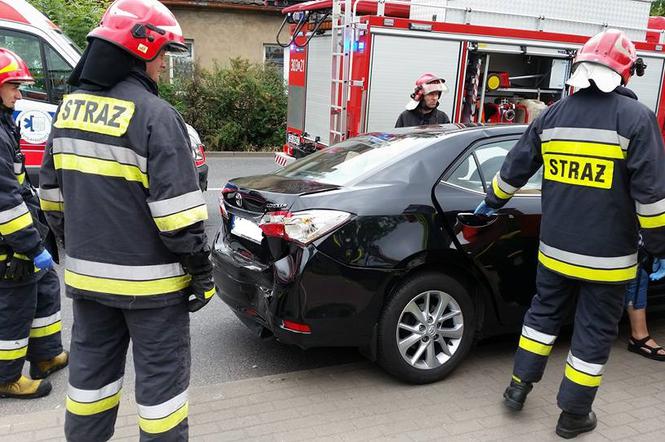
476, 30, 665, 438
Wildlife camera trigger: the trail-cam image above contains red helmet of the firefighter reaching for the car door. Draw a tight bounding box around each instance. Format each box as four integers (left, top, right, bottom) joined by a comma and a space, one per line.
573, 29, 639, 85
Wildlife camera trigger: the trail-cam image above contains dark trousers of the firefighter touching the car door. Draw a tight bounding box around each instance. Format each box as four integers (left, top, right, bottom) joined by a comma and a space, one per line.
513, 265, 626, 414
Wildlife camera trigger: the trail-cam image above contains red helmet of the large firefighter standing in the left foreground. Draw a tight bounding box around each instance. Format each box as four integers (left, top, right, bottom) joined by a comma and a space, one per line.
88, 0, 187, 61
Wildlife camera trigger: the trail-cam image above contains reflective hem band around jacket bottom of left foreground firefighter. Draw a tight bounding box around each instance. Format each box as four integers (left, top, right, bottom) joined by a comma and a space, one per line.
65, 256, 191, 296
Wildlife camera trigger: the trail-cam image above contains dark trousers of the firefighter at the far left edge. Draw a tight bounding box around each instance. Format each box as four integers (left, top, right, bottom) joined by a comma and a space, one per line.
0, 269, 62, 383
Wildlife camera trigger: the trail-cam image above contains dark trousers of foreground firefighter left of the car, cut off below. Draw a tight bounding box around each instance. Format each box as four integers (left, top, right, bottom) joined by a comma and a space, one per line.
65, 299, 191, 442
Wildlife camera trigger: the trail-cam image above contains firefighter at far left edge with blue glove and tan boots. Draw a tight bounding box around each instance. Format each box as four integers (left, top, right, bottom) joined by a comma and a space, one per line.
0, 48, 67, 399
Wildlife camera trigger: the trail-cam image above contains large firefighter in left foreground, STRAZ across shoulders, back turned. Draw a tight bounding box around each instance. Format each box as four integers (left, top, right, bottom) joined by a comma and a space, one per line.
40, 0, 214, 441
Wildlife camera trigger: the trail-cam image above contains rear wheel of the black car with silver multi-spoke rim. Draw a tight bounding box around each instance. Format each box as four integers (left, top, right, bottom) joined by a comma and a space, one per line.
377, 272, 476, 384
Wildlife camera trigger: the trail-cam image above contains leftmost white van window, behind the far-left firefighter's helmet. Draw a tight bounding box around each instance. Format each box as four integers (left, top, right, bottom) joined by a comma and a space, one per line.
0, 29, 48, 101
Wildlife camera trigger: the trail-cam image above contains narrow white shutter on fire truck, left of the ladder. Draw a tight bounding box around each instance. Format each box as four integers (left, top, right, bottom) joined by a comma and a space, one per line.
305, 34, 332, 145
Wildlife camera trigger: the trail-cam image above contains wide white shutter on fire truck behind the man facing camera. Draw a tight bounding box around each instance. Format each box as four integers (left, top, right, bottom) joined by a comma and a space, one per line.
366, 34, 461, 132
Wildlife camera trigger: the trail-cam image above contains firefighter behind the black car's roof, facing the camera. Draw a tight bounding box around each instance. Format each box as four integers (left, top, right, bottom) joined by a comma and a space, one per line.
395, 73, 450, 127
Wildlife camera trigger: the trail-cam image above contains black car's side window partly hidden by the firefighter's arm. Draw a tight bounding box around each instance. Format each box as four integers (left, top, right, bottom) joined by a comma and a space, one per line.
446, 140, 543, 195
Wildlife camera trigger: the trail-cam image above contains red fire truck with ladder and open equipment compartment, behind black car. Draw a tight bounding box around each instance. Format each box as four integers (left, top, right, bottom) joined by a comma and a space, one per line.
275, 0, 665, 165
